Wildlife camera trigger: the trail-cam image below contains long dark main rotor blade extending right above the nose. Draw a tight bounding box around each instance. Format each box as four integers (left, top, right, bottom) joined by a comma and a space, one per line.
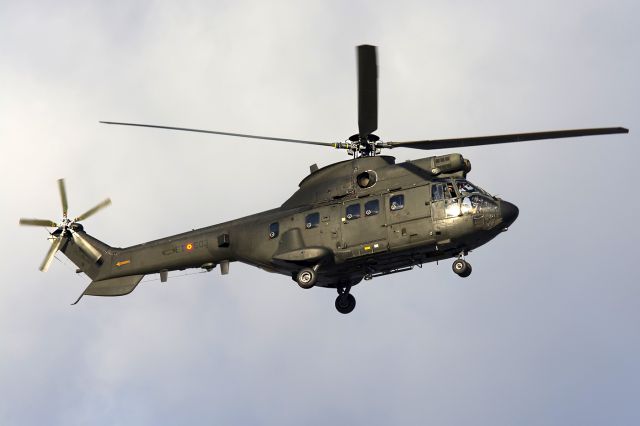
385, 127, 629, 149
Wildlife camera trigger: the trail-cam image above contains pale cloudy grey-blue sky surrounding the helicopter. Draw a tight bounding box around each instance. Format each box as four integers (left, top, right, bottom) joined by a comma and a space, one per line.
0, 0, 640, 425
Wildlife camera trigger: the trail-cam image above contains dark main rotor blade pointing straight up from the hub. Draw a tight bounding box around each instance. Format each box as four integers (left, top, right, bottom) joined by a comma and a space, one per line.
357, 45, 378, 140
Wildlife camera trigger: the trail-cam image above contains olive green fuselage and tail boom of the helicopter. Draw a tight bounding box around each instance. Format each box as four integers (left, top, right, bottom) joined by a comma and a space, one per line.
63, 154, 517, 287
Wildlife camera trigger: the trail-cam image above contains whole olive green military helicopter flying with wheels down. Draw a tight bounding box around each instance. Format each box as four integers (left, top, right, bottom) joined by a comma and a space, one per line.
20, 45, 628, 314
